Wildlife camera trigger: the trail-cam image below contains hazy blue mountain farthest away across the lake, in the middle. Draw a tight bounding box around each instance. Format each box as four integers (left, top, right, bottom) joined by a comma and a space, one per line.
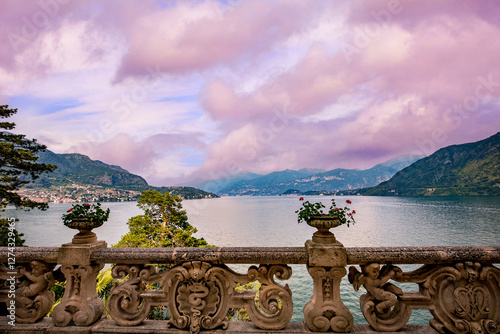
218, 156, 422, 196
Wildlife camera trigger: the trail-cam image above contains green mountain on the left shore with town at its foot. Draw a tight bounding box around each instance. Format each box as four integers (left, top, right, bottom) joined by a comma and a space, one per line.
25, 150, 218, 199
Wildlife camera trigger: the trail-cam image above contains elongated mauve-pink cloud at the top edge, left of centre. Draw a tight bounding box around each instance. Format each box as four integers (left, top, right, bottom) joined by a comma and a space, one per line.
112, 0, 319, 80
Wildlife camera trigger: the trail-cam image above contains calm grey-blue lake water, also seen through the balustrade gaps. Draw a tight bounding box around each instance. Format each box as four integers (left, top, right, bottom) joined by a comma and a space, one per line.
6, 196, 500, 324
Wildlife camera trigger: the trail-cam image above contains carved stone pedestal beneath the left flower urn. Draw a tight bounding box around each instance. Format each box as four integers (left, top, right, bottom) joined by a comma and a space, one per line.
52, 241, 107, 326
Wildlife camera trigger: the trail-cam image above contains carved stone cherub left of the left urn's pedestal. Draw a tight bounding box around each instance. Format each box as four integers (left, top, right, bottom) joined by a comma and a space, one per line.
18, 261, 55, 307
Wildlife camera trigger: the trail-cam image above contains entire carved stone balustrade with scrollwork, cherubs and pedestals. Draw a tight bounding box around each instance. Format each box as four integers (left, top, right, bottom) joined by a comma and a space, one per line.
0, 228, 500, 333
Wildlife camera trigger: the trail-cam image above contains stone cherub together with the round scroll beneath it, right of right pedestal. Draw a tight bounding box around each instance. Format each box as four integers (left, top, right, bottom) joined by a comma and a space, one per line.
348, 263, 412, 332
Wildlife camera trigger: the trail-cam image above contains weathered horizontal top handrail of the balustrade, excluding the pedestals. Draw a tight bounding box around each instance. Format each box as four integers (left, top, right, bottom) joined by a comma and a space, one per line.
0, 246, 500, 264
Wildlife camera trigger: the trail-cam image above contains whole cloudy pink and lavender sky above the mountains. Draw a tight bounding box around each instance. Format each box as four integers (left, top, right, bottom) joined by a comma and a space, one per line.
0, 0, 500, 185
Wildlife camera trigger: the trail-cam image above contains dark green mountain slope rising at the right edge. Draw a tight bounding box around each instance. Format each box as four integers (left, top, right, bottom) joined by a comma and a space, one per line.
362, 132, 500, 196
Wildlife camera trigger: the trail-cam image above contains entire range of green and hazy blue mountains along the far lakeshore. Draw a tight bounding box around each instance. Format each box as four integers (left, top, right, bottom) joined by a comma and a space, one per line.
26, 132, 500, 198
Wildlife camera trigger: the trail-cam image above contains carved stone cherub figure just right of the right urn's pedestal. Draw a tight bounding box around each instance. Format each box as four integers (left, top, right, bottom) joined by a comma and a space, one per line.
348, 263, 403, 313
